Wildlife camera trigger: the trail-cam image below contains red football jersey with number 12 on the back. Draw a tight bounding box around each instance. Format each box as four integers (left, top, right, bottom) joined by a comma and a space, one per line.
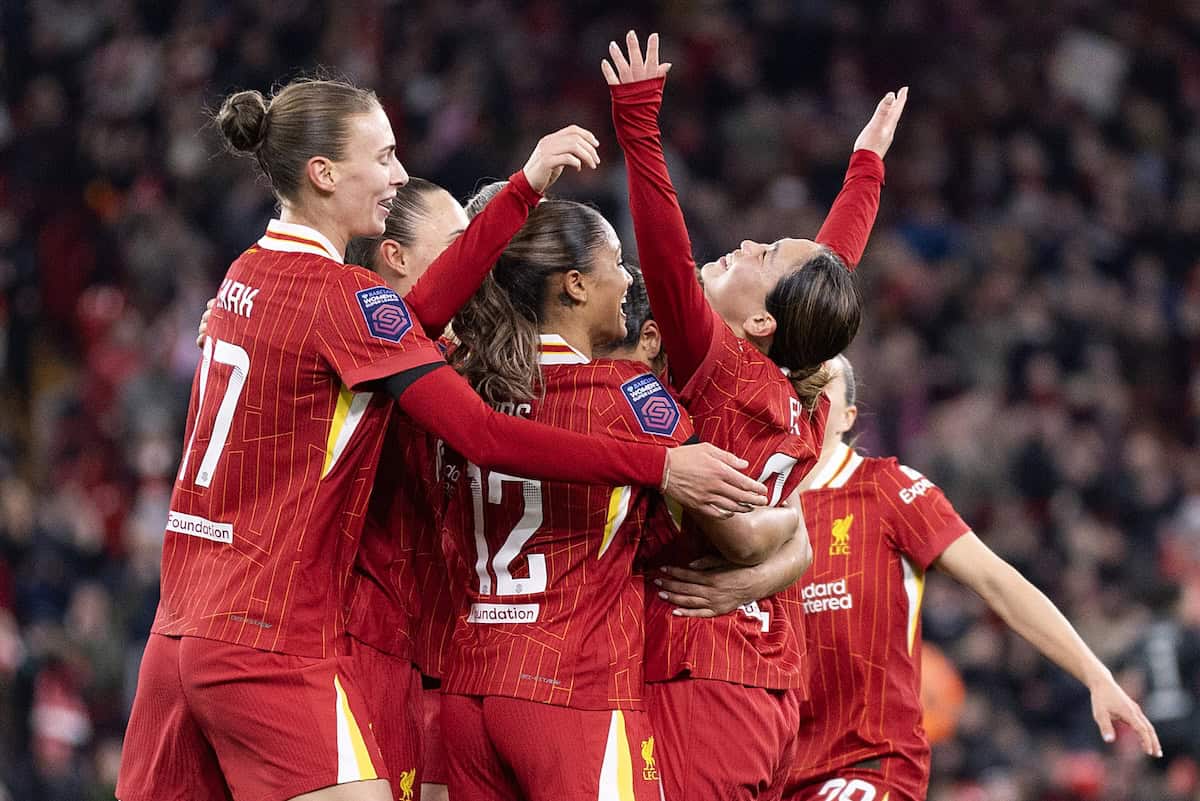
444, 336, 692, 710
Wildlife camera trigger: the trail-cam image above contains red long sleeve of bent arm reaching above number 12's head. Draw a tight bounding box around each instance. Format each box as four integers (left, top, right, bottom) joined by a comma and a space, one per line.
404, 170, 541, 336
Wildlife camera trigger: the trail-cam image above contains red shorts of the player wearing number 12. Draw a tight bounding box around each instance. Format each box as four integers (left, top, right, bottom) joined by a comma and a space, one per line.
442, 694, 661, 801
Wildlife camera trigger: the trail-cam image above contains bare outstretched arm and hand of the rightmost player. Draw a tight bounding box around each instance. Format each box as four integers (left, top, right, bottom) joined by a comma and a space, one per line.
934, 531, 1163, 757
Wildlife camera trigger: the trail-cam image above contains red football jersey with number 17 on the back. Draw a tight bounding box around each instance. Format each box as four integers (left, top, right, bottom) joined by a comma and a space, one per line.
154, 221, 442, 657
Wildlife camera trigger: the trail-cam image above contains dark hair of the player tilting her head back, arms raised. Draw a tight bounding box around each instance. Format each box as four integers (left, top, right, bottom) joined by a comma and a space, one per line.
767, 248, 863, 401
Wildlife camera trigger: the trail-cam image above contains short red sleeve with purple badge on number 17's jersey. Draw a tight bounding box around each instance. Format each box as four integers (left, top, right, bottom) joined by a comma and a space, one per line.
312, 266, 444, 390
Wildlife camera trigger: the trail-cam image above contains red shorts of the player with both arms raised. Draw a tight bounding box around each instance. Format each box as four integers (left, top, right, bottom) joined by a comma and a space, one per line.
646, 679, 800, 801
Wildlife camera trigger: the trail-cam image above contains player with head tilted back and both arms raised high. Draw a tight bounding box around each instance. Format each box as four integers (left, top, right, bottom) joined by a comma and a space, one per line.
602, 31, 907, 801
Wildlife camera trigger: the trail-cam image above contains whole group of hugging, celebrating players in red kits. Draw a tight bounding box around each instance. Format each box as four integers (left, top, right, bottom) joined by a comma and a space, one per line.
118, 32, 1159, 801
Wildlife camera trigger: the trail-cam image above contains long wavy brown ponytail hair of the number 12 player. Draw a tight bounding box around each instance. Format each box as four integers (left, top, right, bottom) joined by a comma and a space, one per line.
450, 195, 608, 404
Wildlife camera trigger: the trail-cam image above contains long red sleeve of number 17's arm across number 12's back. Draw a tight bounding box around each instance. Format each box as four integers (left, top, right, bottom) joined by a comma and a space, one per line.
394, 368, 666, 487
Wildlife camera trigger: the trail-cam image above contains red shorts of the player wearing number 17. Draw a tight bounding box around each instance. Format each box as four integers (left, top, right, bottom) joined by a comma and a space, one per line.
116, 634, 386, 801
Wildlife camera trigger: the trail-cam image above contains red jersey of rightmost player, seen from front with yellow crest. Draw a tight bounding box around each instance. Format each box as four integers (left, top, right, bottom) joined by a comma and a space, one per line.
788, 445, 970, 799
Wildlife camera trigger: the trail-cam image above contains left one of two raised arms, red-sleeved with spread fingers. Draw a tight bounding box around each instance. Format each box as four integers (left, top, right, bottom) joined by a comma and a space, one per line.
602, 31, 715, 387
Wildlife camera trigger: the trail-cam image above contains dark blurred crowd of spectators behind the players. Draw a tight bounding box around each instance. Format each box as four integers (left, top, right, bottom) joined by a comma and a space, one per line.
0, 0, 1200, 801
